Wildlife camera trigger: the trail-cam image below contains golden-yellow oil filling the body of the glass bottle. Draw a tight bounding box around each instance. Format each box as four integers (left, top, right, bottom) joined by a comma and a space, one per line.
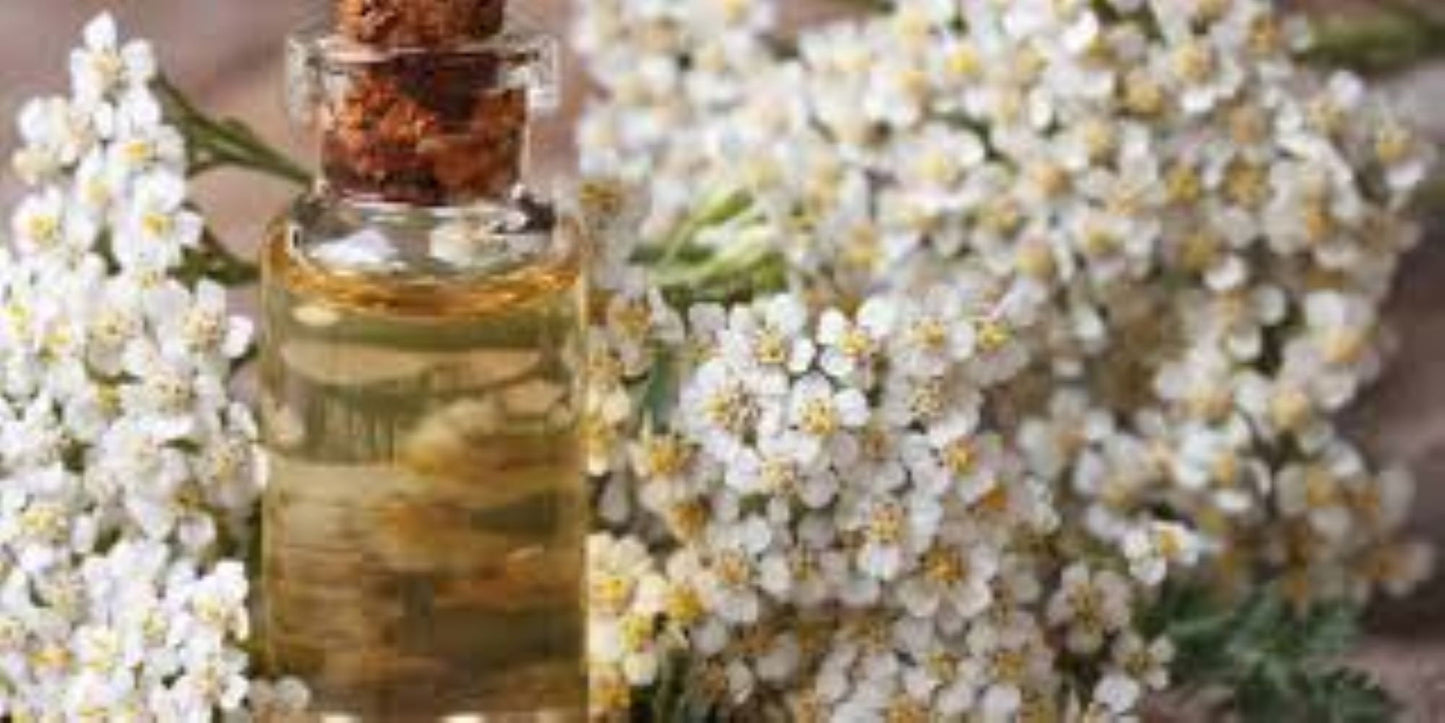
262, 226, 587, 722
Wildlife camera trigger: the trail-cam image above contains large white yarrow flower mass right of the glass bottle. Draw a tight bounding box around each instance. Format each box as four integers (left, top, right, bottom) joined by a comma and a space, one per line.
575, 0, 1432, 722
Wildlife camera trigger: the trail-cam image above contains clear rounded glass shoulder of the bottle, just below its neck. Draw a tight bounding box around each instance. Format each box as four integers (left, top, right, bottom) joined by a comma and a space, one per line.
262, 194, 588, 315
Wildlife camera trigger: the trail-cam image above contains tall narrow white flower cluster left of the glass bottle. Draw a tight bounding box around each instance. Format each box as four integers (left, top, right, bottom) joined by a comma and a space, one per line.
0, 16, 305, 720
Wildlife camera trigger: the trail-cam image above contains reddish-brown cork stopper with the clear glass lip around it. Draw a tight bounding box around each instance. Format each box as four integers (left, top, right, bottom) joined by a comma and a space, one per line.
305, 0, 553, 207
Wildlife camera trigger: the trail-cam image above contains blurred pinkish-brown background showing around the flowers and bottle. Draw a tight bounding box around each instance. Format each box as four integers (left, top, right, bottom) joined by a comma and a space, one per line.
8, 0, 1445, 722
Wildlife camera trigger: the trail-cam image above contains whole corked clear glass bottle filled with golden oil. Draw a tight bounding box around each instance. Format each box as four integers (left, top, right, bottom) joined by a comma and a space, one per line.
262, 0, 587, 720
